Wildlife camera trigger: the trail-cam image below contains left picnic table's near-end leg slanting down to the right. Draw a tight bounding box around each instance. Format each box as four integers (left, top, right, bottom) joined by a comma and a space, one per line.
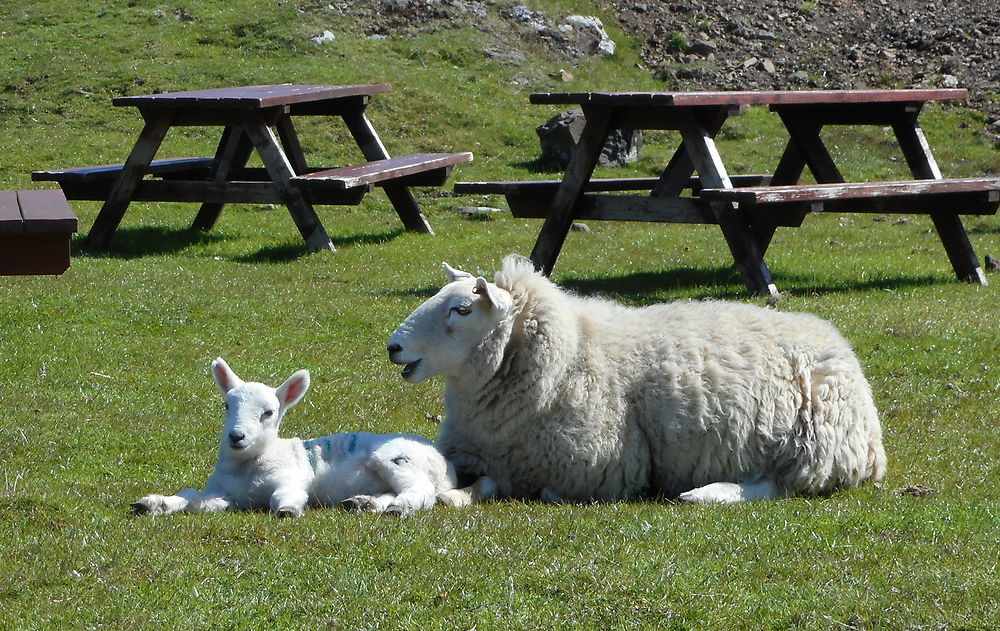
244, 114, 336, 252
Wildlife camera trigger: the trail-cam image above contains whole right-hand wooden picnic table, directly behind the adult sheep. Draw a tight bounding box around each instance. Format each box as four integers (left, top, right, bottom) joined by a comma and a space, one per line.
455, 89, 1000, 294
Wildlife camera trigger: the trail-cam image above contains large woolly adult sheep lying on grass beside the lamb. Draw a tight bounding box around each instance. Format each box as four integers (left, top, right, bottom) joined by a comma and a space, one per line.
388, 256, 886, 505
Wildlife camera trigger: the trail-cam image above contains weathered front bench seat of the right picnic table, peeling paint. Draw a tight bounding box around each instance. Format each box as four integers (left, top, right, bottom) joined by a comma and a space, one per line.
698, 177, 1000, 215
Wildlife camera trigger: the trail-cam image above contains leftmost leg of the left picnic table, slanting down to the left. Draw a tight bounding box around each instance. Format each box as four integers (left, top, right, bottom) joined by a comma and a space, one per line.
84, 115, 170, 250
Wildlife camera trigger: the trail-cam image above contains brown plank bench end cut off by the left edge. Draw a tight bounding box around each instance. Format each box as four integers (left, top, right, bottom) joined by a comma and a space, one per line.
0, 190, 78, 276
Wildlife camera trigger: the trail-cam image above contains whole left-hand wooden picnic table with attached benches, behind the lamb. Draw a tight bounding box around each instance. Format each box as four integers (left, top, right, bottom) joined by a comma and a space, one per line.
32, 84, 472, 251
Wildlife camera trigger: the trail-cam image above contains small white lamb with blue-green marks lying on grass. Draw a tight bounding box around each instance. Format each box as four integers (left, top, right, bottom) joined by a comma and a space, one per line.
132, 358, 455, 517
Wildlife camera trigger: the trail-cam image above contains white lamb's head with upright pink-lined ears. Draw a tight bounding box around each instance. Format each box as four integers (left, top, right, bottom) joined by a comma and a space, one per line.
212, 357, 309, 457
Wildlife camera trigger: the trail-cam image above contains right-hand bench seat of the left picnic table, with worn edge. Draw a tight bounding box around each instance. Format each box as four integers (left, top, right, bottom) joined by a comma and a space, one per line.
291, 152, 472, 190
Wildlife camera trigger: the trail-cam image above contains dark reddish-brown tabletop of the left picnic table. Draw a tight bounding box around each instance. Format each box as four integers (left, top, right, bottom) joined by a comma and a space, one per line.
111, 83, 392, 110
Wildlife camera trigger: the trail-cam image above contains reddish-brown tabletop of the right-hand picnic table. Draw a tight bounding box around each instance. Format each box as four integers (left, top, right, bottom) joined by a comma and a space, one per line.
528, 88, 969, 107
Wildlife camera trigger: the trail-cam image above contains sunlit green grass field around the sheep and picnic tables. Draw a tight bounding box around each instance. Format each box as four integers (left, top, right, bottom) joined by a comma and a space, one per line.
0, 0, 1000, 631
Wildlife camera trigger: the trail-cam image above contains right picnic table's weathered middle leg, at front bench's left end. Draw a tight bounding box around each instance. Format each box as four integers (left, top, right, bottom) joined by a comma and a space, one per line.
678, 113, 778, 296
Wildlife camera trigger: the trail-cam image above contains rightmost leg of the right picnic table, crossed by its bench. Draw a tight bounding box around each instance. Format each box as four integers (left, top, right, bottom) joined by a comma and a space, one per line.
892, 112, 989, 286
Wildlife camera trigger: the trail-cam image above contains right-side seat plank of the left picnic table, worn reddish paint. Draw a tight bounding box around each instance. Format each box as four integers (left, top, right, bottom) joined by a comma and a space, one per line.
292, 152, 472, 189
